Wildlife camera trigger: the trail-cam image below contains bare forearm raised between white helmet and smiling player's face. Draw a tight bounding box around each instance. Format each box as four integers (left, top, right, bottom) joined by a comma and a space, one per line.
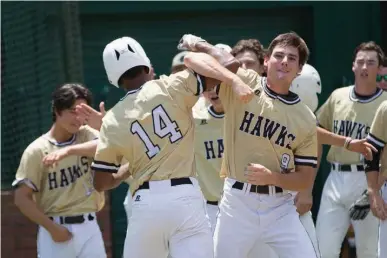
184, 53, 239, 85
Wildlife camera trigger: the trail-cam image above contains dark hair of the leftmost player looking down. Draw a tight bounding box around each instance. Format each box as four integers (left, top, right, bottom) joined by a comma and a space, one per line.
51, 83, 93, 122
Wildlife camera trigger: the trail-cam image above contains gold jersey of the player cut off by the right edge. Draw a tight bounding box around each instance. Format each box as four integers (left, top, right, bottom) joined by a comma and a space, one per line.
367, 101, 387, 177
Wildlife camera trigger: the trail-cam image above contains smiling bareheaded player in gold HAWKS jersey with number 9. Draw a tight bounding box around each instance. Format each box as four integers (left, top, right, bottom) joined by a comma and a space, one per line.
185, 33, 317, 258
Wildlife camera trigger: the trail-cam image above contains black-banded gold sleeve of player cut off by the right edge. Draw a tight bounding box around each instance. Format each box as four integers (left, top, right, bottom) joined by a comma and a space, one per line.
365, 101, 387, 172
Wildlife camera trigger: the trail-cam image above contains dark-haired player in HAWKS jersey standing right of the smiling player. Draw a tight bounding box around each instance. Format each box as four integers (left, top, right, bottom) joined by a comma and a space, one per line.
316, 42, 387, 258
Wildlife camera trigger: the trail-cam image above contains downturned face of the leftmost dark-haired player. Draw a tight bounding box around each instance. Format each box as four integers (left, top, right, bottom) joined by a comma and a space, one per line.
56, 99, 87, 134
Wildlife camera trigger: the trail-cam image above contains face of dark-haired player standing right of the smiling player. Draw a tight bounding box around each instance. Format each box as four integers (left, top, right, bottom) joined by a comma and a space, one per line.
352, 51, 379, 83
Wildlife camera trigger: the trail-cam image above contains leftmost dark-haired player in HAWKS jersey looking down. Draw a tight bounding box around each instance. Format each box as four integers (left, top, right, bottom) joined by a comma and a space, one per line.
13, 83, 106, 258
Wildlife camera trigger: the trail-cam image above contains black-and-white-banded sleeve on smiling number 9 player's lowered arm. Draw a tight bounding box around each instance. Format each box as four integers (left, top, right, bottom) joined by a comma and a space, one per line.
294, 126, 317, 168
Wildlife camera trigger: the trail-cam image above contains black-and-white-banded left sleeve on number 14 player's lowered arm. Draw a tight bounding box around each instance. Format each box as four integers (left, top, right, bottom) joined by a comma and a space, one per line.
91, 120, 122, 173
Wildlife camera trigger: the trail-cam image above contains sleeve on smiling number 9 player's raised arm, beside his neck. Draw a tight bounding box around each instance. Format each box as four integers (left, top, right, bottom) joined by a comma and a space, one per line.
215, 68, 259, 113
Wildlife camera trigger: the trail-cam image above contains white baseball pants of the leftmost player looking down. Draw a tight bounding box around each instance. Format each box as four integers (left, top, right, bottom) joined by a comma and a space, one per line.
37, 213, 106, 258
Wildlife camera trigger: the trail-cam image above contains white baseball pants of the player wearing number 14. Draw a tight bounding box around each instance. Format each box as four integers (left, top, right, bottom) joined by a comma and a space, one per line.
124, 178, 213, 258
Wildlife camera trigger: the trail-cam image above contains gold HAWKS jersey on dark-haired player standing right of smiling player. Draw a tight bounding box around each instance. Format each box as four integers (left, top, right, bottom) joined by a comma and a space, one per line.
317, 86, 387, 164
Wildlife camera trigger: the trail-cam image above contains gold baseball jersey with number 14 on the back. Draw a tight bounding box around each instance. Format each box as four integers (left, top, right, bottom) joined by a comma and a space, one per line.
92, 70, 205, 191
